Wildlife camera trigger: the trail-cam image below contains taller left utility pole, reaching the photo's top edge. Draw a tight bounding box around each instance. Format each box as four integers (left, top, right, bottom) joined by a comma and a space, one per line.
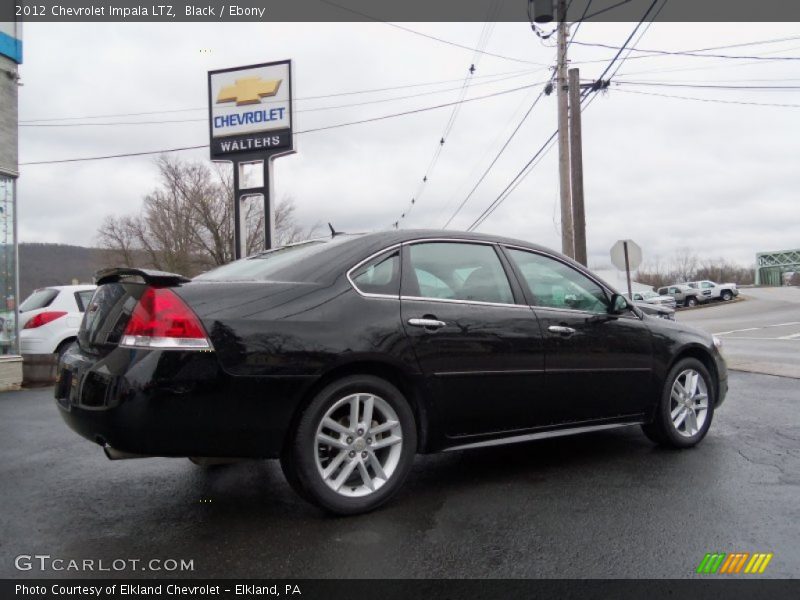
556, 0, 575, 258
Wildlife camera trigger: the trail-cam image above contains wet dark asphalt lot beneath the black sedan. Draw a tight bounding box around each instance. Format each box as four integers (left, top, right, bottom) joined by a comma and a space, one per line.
0, 370, 800, 578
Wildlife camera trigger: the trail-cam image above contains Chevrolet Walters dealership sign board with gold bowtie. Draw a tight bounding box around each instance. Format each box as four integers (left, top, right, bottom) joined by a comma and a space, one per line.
208, 60, 293, 159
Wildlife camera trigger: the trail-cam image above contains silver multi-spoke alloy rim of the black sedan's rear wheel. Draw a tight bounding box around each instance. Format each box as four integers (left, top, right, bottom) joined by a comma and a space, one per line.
314, 393, 403, 497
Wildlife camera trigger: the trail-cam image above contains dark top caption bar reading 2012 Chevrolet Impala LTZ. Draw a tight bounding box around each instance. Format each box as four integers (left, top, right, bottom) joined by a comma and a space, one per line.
6, 0, 800, 23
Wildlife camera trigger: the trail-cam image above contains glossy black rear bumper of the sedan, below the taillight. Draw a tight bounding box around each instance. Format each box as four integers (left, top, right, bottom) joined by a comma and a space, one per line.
55, 348, 310, 458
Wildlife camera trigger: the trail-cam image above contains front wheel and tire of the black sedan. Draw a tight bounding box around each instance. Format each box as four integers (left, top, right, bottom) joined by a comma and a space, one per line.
642, 358, 716, 448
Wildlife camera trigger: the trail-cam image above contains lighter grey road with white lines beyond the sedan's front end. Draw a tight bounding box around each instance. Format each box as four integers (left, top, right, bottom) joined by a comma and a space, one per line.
676, 287, 800, 379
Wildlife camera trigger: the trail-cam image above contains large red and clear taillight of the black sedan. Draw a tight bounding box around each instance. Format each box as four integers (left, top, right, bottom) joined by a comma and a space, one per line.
120, 287, 211, 350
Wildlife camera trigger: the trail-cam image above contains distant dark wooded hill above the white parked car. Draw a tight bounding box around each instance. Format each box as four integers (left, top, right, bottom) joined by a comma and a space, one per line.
19, 243, 111, 301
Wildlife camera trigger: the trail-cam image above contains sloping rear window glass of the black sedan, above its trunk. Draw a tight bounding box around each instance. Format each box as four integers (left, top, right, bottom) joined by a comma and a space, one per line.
195, 240, 329, 281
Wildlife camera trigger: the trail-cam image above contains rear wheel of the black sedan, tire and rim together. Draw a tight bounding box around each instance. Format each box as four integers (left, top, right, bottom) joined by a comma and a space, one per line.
281, 375, 417, 515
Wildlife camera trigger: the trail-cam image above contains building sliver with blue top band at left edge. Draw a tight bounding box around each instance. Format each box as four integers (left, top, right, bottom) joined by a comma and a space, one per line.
0, 22, 22, 390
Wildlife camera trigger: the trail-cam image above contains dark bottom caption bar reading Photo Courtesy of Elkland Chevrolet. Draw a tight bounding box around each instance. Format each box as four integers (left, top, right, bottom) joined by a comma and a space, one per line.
0, 575, 800, 600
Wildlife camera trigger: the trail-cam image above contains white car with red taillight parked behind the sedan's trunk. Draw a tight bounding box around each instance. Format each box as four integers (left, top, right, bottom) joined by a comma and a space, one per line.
19, 285, 97, 354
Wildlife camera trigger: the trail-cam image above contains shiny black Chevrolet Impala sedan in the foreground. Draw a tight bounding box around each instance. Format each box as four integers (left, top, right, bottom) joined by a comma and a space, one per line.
55, 231, 727, 514
